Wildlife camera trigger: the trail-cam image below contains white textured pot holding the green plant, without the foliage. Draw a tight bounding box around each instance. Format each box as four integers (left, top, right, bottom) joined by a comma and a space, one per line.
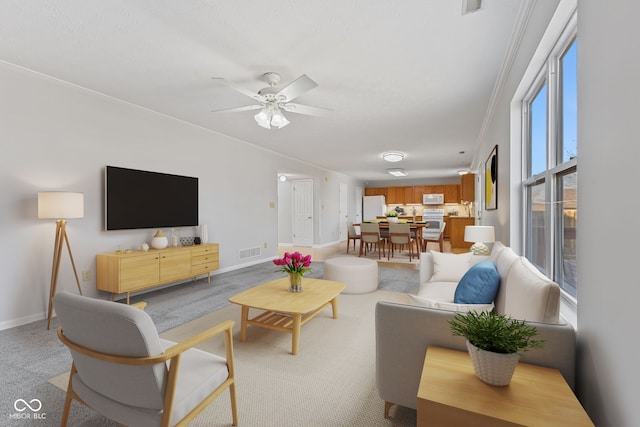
467, 341, 520, 386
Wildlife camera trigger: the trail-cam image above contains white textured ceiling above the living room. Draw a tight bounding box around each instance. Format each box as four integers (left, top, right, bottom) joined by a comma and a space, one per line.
0, 0, 525, 181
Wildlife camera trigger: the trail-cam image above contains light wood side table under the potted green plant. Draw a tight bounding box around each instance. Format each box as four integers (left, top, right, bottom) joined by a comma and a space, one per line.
418, 347, 593, 427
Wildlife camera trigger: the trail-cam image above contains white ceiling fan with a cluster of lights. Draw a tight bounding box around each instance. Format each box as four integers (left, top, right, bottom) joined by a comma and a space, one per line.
213, 72, 332, 129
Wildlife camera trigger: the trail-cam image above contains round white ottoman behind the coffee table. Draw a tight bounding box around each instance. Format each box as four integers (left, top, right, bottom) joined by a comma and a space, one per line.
324, 257, 378, 294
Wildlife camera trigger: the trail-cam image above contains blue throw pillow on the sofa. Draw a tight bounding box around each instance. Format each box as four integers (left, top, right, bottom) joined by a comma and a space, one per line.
453, 260, 500, 304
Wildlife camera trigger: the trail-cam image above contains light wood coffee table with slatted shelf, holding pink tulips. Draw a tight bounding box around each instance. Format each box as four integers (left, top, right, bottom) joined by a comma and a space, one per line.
229, 278, 346, 355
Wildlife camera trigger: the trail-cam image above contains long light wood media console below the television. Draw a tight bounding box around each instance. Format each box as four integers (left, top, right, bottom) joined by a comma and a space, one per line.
96, 243, 219, 304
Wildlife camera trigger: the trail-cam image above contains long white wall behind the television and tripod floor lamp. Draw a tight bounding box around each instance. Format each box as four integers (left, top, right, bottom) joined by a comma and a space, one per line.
0, 63, 361, 329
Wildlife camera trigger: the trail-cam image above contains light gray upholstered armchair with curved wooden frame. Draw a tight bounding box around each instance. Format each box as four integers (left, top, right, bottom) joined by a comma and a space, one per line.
53, 292, 238, 426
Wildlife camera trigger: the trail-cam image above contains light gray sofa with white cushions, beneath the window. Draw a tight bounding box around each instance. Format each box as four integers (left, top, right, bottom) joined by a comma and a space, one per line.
375, 242, 576, 417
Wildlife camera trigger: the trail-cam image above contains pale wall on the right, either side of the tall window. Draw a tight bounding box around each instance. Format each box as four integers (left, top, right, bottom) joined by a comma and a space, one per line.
479, 0, 640, 427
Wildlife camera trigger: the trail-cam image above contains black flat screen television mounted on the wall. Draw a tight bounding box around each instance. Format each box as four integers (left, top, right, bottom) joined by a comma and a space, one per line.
104, 166, 198, 230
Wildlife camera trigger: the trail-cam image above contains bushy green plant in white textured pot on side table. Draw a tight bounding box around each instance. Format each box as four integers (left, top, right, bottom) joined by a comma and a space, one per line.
449, 311, 544, 386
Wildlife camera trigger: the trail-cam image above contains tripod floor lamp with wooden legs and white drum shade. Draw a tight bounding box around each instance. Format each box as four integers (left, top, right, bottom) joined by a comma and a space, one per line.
38, 191, 84, 329
